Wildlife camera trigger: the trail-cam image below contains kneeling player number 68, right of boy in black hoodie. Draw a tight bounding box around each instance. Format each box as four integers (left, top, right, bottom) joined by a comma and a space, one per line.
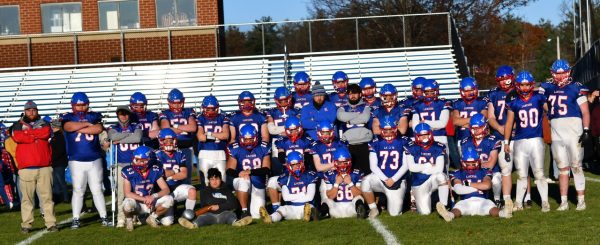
227, 124, 271, 219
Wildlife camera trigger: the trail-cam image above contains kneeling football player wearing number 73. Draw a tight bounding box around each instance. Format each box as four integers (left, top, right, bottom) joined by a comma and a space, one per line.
361, 116, 409, 218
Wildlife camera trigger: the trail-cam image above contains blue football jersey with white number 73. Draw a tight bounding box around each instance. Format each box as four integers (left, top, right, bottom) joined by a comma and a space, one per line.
369, 137, 410, 180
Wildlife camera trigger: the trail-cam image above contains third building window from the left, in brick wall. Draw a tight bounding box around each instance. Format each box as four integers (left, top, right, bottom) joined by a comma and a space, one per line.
98, 0, 140, 31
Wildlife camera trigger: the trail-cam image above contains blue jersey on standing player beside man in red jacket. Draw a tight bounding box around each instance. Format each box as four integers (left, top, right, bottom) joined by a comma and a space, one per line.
60, 111, 103, 162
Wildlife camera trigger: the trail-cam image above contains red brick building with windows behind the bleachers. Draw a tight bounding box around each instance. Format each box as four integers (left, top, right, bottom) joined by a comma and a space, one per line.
0, 0, 224, 68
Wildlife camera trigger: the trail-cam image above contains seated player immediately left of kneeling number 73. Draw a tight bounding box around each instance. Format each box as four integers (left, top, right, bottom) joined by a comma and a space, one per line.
323, 148, 367, 218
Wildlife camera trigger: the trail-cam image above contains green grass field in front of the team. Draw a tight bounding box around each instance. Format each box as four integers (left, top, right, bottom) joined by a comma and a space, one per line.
0, 167, 600, 244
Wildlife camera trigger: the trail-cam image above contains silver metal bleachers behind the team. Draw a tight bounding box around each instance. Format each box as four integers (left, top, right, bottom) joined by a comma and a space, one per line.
0, 45, 459, 122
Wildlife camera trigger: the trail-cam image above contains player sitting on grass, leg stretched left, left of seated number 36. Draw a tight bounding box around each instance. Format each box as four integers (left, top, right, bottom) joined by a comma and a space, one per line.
260, 151, 318, 224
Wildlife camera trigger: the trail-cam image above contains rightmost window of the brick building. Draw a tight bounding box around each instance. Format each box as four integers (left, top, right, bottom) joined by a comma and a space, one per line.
156, 0, 196, 27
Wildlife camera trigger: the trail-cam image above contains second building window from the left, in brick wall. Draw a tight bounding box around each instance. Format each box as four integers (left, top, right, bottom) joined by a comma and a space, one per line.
42, 3, 82, 33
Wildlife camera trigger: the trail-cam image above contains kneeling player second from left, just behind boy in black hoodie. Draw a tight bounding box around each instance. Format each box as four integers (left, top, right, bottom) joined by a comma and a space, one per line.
156, 128, 196, 226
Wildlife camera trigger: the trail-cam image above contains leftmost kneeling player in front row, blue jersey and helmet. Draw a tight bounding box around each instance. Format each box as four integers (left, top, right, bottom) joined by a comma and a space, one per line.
121, 146, 173, 231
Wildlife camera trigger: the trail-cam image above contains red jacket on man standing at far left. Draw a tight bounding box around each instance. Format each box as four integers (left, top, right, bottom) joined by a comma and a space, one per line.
11, 119, 52, 169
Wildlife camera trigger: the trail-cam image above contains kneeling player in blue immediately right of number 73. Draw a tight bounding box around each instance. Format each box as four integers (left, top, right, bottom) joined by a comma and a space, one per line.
403, 123, 449, 215
